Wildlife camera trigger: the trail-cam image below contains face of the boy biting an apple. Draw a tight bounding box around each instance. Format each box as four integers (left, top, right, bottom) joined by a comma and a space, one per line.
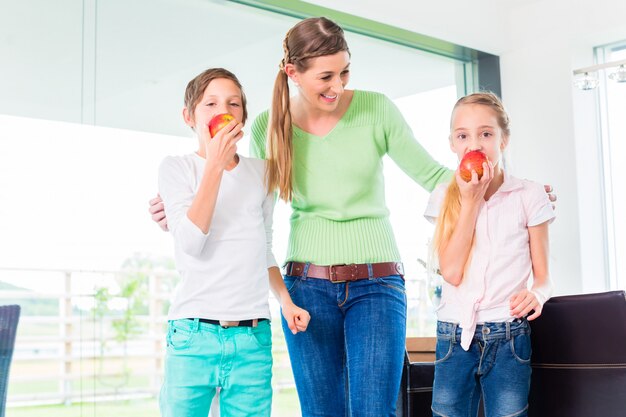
184, 78, 243, 133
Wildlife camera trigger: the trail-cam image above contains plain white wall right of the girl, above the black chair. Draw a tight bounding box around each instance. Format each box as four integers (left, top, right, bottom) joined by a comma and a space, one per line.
499, 0, 626, 293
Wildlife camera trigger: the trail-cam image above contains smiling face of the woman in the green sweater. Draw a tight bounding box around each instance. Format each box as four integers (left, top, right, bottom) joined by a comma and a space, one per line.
285, 51, 350, 112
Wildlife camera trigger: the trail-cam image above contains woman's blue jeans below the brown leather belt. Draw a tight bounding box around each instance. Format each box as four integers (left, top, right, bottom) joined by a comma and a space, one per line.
283, 275, 406, 417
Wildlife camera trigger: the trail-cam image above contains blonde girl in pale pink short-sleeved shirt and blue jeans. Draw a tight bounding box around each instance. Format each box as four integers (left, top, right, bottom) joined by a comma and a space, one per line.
425, 93, 554, 417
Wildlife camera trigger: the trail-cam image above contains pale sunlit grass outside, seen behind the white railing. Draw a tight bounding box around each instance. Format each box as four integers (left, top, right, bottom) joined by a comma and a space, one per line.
6, 320, 300, 417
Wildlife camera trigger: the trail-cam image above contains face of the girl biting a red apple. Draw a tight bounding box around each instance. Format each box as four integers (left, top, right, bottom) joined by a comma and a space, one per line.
450, 104, 508, 167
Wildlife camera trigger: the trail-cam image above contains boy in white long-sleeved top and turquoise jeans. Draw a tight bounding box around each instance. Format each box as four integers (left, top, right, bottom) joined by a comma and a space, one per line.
159, 68, 309, 417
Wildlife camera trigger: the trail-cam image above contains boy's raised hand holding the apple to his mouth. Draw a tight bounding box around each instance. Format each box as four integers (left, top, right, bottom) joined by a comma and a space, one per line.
205, 120, 243, 170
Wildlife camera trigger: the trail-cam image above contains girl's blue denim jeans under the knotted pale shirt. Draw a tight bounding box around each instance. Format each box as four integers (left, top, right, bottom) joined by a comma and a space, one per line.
432, 319, 531, 417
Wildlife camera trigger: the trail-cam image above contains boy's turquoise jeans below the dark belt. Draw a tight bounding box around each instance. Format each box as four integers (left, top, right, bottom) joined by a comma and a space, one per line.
159, 319, 272, 417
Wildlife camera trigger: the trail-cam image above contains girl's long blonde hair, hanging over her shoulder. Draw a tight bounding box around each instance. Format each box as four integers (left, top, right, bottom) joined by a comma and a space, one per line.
430, 92, 511, 276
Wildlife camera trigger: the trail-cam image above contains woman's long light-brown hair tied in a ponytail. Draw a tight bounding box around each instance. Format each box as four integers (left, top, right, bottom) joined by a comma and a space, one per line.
266, 17, 350, 201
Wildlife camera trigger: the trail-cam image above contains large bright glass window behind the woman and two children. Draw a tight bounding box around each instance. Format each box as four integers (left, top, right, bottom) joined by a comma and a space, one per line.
0, 0, 466, 417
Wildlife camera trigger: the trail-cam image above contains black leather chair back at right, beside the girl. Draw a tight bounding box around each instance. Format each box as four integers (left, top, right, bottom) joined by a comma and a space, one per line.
528, 291, 626, 417
